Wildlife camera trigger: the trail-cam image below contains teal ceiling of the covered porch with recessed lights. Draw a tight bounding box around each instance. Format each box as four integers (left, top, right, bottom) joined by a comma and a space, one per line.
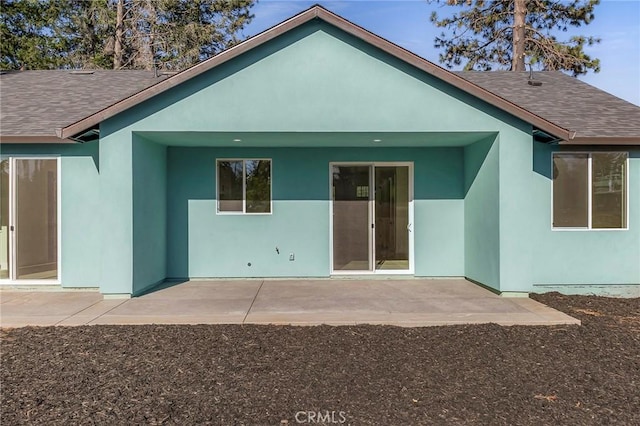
136, 131, 496, 148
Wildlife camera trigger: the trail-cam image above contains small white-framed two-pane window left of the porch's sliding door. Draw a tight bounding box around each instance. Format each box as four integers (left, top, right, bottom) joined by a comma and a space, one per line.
216, 159, 271, 214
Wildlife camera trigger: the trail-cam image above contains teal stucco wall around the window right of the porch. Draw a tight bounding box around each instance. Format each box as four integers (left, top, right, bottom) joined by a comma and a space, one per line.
523, 144, 640, 297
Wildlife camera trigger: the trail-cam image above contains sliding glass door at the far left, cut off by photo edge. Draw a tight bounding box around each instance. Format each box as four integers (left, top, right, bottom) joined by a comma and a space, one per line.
0, 158, 59, 282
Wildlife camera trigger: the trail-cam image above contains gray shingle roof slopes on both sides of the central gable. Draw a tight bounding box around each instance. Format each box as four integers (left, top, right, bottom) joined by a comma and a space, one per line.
0, 70, 640, 138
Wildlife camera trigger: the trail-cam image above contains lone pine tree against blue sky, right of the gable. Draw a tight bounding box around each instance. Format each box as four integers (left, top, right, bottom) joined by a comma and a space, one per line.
431, 0, 600, 76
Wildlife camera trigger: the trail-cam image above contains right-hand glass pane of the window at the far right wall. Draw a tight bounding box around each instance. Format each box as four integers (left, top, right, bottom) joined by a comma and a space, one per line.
591, 152, 627, 228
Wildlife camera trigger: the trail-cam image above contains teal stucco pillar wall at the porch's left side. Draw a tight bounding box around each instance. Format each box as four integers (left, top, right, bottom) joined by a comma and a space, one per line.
95, 123, 167, 294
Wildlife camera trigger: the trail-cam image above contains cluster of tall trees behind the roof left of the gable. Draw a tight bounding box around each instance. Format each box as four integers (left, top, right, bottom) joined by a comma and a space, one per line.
0, 0, 255, 70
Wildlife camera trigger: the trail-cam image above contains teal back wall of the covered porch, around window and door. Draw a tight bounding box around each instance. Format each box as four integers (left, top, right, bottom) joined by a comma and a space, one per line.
167, 147, 464, 278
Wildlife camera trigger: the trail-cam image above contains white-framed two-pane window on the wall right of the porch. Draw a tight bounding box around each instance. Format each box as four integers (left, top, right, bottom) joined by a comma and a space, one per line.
552, 152, 629, 229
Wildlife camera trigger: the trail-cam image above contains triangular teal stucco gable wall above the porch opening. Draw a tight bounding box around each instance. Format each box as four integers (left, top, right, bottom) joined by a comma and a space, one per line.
103, 21, 518, 136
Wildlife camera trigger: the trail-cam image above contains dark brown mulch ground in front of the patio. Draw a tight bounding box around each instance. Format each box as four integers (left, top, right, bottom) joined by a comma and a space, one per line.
0, 293, 640, 425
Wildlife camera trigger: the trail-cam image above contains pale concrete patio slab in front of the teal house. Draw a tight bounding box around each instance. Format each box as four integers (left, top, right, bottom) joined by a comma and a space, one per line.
0, 279, 580, 327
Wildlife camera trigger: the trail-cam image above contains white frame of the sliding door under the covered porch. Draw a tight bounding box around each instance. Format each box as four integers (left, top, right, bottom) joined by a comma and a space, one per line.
329, 161, 415, 276
